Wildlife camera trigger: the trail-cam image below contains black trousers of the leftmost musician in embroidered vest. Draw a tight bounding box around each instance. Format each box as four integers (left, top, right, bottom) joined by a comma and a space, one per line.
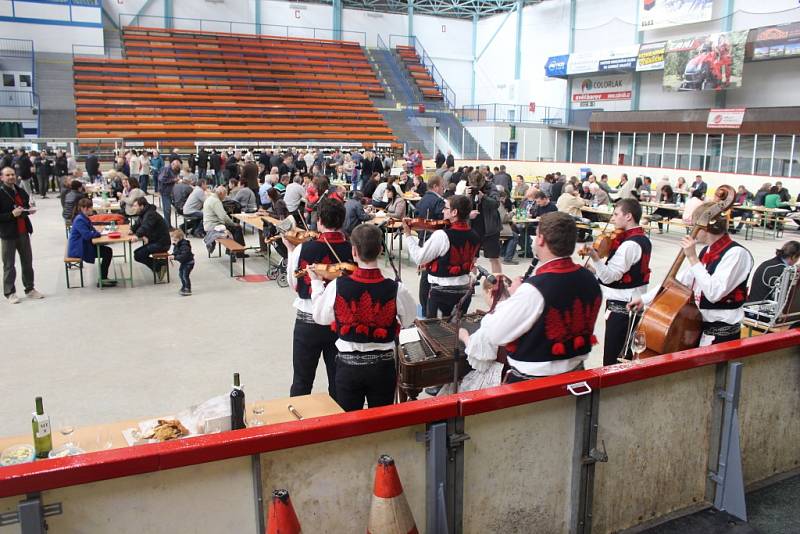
289, 320, 339, 399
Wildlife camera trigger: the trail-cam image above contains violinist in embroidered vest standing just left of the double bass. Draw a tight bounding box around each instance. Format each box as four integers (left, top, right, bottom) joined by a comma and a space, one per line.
588, 198, 653, 365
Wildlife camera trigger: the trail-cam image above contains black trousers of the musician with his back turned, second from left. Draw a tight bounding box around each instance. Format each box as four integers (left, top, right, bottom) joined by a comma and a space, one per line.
336, 358, 397, 412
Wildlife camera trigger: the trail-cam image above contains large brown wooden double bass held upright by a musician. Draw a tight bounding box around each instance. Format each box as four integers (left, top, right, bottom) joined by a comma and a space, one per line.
638, 185, 736, 357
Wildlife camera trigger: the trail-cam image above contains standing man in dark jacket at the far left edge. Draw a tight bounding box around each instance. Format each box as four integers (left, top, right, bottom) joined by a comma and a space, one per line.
0, 167, 44, 304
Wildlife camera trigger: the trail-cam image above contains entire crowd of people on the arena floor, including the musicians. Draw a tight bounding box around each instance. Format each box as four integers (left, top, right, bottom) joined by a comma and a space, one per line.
0, 147, 800, 410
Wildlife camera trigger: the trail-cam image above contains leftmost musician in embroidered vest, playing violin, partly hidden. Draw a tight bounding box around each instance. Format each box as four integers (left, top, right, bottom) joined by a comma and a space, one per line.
283, 198, 353, 399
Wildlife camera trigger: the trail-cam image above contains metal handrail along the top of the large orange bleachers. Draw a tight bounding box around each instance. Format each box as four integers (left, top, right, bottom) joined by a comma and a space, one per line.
118, 13, 367, 46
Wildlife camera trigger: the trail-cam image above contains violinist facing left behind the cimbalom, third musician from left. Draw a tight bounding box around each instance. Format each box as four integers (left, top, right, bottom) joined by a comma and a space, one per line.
403, 195, 481, 319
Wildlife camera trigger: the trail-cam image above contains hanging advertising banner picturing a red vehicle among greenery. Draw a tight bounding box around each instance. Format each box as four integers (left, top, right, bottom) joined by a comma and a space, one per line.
664, 31, 747, 91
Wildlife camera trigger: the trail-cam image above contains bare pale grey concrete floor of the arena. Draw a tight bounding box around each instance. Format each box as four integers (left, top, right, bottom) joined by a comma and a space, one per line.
0, 196, 797, 436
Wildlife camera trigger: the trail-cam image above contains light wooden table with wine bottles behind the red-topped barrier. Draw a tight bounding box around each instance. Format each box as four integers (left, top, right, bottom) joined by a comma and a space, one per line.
0, 393, 343, 460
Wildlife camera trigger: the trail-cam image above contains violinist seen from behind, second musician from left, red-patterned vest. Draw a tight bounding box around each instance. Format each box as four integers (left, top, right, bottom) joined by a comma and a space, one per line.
309, 224, 416, 412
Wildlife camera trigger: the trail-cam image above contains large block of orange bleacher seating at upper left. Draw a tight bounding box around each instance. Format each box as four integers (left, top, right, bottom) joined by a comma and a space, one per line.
74, 27, 394, 146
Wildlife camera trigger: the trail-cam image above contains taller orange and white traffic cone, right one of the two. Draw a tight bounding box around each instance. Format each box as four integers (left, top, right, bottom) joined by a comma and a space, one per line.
367, 454, 418, 534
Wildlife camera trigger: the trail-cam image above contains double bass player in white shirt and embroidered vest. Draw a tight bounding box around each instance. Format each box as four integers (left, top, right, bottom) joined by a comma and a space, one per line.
629, 209, 753, 347
